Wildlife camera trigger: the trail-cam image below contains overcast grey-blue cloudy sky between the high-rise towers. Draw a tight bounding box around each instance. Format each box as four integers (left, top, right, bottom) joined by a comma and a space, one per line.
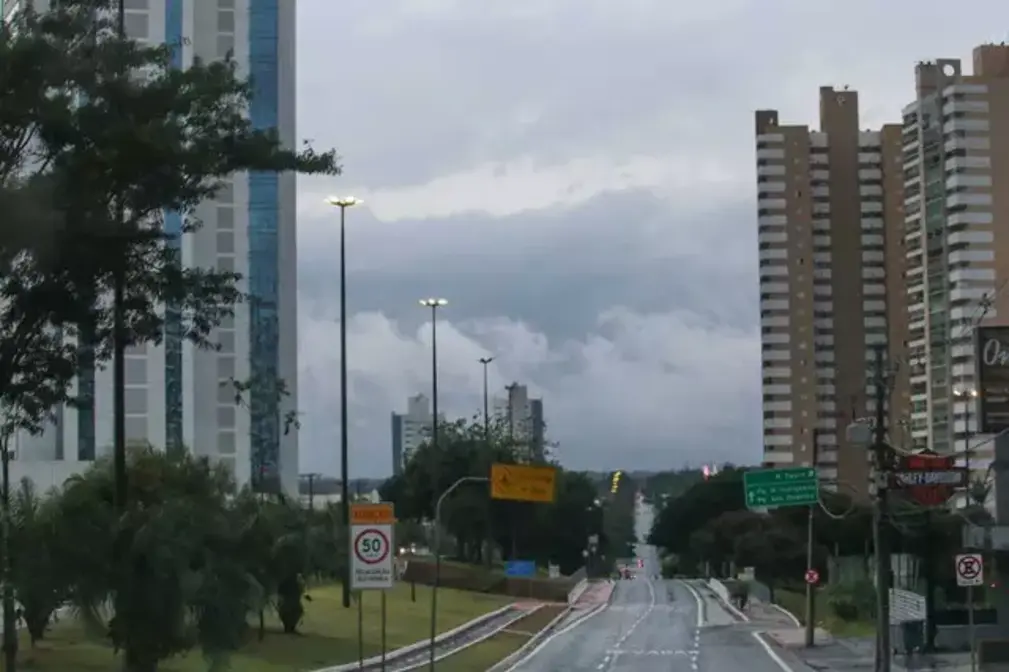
298, 0, 1009, 476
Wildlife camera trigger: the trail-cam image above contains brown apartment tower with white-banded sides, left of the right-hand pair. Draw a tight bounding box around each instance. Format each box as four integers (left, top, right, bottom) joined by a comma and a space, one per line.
755, 87, 907, 492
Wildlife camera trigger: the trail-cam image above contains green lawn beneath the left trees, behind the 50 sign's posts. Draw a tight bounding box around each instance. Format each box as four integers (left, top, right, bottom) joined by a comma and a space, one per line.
19, 584, 511, 672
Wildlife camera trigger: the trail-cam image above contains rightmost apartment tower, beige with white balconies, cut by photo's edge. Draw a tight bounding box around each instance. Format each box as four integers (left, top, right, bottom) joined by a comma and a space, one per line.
903, 44, 1009, 468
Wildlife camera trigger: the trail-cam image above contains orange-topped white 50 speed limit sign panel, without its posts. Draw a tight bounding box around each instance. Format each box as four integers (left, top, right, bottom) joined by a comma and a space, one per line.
350, 502, 396, 590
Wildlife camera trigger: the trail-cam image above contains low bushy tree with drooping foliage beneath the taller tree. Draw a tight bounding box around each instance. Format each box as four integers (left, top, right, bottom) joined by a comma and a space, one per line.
59, 447, 263, 672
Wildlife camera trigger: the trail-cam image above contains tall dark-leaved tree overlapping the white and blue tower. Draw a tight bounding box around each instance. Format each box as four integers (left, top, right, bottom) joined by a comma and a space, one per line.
0, 0, 338, 482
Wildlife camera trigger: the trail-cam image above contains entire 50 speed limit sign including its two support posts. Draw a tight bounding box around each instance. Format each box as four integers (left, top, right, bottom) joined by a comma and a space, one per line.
349, 501, 396, 665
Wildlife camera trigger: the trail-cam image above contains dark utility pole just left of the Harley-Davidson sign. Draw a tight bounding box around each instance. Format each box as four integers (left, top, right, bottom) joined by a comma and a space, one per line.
873, 345, 890, 672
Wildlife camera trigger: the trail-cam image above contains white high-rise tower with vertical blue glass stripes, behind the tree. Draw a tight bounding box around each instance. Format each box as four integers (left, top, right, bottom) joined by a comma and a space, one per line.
3, 0, 298, 492
